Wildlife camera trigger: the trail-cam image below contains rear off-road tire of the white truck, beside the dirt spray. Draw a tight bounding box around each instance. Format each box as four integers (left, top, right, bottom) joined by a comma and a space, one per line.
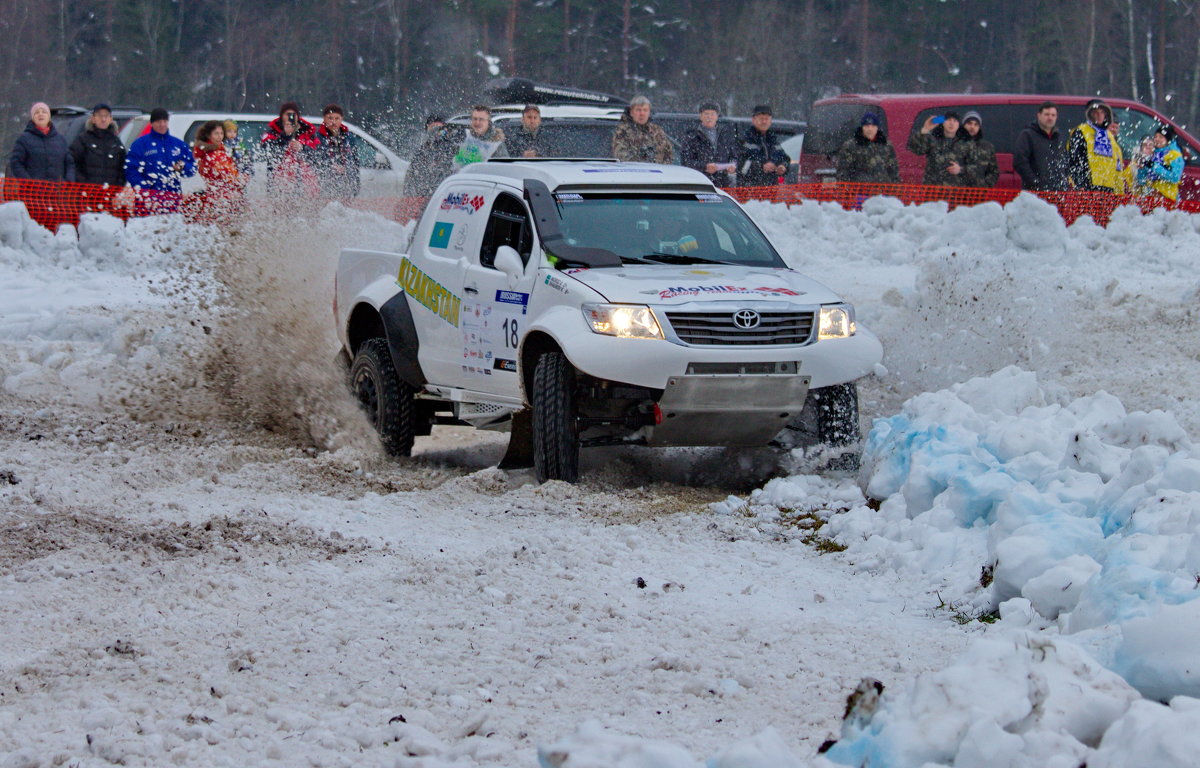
350, 338, 416, 456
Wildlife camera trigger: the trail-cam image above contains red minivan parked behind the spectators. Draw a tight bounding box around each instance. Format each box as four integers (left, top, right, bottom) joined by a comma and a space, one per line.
799, 94, 1200, 199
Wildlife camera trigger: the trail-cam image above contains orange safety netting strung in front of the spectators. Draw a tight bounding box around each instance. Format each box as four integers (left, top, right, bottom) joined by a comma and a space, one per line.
0, 179, 1200, 230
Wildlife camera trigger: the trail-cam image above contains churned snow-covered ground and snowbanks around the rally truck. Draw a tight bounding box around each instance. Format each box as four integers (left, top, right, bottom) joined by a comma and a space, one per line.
0, 197, 1200, 768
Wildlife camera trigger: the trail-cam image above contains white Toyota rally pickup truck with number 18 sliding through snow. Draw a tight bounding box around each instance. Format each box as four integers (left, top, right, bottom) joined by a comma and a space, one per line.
335, 160, 882, 482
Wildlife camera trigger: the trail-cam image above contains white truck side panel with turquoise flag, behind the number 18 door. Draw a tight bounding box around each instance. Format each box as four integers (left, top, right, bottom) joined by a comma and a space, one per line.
397, 181, 496, 389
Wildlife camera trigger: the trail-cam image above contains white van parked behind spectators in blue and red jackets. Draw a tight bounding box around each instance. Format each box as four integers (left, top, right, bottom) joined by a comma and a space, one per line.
120, 112, 408, 197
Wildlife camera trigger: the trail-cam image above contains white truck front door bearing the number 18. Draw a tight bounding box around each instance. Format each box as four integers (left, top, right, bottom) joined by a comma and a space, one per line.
462, 187, 538, 397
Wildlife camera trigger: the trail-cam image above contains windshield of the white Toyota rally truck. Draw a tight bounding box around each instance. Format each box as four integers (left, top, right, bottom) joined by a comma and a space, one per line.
554, 192, 785, 268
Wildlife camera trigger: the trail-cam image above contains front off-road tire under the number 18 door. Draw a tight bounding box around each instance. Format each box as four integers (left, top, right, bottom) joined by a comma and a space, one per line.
530, 352, 580, 482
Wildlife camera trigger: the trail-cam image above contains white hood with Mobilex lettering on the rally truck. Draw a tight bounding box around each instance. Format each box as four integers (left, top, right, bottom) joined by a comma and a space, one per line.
565, 264, 841, 306
